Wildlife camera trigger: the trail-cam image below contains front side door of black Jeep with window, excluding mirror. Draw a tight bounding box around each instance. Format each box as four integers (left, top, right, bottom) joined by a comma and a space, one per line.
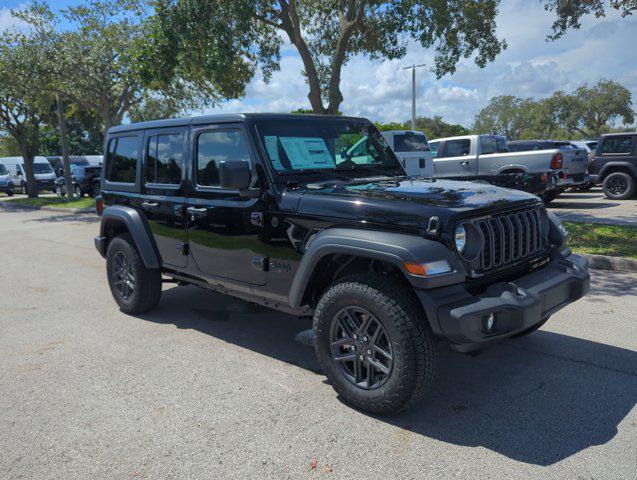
186, 125, 267, 285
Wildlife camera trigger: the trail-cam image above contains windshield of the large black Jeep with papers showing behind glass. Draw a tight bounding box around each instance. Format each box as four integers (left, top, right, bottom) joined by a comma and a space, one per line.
256, 117, 404, 175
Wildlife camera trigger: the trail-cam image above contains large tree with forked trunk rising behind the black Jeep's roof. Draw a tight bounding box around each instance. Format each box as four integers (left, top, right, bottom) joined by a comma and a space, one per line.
143, 0, 506, 113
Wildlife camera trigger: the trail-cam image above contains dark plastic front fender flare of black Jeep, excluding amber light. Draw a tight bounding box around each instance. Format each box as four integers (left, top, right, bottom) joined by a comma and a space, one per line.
289, 228, 466, 308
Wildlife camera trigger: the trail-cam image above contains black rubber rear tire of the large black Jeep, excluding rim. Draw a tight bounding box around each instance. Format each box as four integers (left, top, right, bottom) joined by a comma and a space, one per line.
106, 233, 162, 314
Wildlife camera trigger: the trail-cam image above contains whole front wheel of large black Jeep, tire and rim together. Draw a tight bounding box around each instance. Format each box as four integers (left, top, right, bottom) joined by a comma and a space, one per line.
314, 274, 437, 414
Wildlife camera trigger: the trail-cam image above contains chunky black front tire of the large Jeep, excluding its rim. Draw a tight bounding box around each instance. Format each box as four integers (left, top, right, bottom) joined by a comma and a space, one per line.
314, 274, 437, 414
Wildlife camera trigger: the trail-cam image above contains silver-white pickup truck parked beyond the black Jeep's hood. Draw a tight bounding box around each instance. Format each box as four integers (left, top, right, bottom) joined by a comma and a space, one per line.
429, 135, 587, 202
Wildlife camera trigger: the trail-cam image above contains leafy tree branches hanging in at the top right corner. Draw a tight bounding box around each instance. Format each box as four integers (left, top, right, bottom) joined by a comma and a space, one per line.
544, 0, 637, 40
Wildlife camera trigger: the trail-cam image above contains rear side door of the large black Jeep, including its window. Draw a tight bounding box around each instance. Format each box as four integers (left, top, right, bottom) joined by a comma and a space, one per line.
139, 128, 188, 267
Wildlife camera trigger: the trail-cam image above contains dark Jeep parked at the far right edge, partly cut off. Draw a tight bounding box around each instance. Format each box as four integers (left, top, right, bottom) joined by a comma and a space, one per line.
588, 132, 637, 200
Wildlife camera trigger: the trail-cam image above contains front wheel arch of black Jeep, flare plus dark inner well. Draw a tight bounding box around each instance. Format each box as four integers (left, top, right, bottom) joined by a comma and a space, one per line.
289, 228, 465, 308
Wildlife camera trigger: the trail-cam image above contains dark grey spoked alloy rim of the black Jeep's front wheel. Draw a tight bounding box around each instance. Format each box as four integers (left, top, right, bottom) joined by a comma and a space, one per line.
330, 307, 394, 390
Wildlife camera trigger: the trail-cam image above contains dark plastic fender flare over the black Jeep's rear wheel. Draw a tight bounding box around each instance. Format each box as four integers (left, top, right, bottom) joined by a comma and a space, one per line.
100, 205, 160, 269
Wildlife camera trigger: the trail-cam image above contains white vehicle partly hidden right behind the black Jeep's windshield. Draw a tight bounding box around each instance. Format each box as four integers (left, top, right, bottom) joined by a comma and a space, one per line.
381, 130, 434, 177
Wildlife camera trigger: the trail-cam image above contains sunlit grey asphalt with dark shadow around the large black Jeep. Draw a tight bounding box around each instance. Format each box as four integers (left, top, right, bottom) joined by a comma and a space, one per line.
0, 209, 637, 479
